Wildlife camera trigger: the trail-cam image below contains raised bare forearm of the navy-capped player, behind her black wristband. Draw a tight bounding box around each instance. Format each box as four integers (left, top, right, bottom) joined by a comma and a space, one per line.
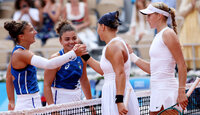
87, 57, 103, 75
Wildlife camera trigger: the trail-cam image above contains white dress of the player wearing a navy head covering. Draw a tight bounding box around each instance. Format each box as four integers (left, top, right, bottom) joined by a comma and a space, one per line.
100, 37, 139, 115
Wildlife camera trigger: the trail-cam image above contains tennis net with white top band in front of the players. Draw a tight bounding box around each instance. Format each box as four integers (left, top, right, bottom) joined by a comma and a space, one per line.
0, 84, 200, 115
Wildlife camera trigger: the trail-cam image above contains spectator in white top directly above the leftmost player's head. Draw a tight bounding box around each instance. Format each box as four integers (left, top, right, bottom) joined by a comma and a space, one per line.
13, 0, 39, 27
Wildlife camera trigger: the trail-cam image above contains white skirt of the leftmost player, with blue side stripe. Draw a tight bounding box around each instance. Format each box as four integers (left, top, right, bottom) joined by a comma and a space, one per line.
15, 92, 42, 110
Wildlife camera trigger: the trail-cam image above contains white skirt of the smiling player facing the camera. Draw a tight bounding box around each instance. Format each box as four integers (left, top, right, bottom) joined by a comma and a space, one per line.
51, 87, 81, 104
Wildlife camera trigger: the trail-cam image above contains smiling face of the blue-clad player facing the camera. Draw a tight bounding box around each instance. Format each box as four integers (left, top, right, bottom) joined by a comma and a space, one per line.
60, 31, 78, 51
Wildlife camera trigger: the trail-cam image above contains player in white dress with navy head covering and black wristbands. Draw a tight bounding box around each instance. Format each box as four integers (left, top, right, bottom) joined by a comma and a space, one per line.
86, 11, 140, 115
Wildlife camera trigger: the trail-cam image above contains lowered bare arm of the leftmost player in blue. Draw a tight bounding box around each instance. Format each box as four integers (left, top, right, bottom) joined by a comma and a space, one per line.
6, 63, 15, 110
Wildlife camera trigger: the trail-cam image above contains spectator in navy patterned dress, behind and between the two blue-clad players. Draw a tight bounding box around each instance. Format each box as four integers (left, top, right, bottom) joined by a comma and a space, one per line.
35, 0, 61, 46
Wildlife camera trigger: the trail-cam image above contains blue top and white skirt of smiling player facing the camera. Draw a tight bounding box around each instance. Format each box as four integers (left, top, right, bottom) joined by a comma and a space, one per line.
52, 49, 83, 104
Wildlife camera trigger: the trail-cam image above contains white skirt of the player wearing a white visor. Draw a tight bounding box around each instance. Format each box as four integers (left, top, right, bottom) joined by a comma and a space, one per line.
150, 77, 178, 112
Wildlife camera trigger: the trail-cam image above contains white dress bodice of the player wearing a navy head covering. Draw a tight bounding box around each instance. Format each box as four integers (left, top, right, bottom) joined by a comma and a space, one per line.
100, 37, 131, 80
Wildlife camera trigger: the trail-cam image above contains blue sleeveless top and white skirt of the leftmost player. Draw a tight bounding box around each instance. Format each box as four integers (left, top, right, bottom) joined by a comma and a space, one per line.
11, 45, 41, 110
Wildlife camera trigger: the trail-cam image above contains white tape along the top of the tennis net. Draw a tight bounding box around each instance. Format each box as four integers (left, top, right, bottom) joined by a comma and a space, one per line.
0, 83, 200, 115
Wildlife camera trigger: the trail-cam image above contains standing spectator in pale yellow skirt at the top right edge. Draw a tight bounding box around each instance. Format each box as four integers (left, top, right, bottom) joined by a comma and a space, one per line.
179, 0, 200, 69
